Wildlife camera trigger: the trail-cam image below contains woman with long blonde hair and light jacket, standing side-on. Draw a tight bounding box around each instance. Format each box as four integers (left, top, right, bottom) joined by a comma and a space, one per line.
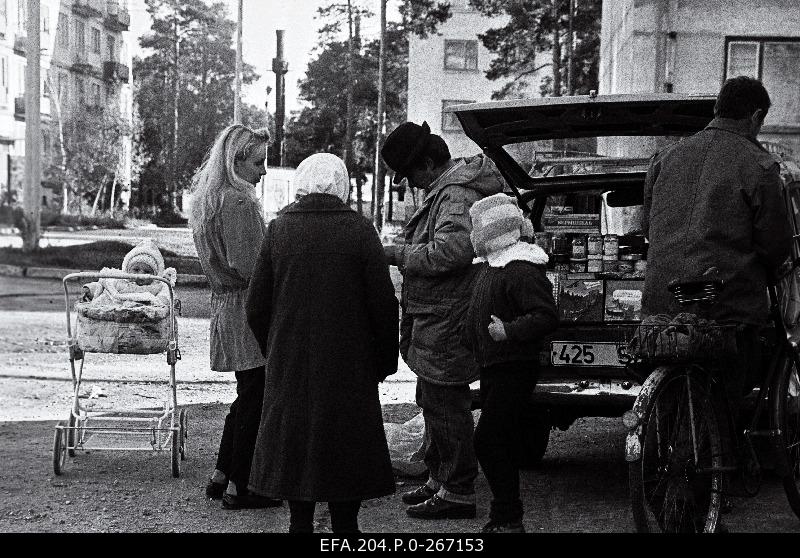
190, 124, 281, 509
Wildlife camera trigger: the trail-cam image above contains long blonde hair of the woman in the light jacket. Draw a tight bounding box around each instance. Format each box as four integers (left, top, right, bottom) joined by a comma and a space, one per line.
189, 124, 269, 230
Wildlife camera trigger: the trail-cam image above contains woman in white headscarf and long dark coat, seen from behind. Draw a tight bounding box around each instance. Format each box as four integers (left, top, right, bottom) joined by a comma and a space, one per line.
247, 153, 398, 533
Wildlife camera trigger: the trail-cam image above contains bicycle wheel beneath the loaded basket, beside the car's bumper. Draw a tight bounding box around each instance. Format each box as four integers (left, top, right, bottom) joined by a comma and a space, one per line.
628, 372, 722, 533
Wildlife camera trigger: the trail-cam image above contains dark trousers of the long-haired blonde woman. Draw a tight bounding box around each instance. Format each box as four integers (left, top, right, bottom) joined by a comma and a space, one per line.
216, 366, 264, 494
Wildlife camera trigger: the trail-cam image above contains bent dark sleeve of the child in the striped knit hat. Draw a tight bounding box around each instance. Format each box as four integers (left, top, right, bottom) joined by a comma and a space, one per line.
504, 264, 558, 341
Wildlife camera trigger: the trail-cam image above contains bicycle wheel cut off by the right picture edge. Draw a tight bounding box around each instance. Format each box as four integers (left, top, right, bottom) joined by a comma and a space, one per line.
769, 352, 800, 517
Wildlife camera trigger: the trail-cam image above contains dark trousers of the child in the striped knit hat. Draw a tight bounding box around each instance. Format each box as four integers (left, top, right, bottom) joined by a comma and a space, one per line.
475, 361, 538, 523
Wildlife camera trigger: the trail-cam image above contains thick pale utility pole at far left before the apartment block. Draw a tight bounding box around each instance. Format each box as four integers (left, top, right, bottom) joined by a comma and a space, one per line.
22, 0, 42, 252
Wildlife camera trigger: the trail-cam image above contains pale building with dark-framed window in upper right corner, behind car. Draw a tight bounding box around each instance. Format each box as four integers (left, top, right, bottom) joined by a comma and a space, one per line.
600, 0, 800, 159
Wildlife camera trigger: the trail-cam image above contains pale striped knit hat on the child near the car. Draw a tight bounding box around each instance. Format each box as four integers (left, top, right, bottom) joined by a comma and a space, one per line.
469, 194, 532, 256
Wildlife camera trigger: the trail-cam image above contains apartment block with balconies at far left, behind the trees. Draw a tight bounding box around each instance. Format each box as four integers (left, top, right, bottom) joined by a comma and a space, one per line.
0, 0, 133, 207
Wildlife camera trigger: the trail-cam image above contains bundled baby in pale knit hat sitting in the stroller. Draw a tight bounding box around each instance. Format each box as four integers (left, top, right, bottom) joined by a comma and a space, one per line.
81, 239, 176, 307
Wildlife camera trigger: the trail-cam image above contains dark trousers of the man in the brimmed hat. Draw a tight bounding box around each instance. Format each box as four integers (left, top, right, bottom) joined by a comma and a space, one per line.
416, 379, 478, 504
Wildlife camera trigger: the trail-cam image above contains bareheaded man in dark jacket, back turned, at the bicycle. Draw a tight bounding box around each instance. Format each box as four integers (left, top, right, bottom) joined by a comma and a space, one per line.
642, 76, 792, 480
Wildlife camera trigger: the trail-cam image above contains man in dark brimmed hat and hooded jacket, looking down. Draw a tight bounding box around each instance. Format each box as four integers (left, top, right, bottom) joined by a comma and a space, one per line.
381, 122, 504, 519
